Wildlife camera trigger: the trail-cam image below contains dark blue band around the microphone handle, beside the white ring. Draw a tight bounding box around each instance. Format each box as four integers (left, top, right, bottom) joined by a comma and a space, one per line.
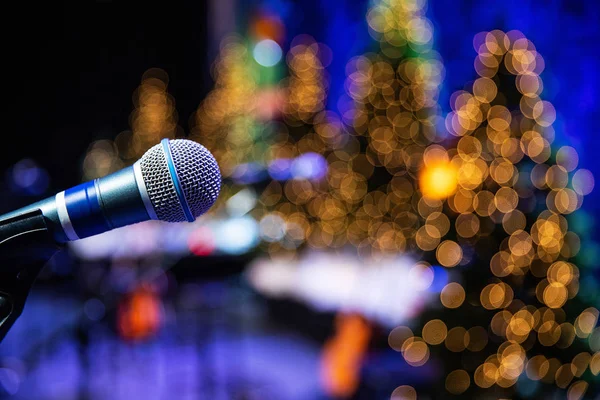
65, 181, 112, 237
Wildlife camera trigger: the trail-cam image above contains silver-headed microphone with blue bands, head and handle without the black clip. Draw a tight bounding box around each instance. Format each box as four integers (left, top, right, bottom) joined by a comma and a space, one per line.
0, 139, 221, 243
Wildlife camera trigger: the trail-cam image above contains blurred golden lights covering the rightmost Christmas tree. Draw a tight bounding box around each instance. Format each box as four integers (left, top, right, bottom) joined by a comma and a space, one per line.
389, 25, 600, 399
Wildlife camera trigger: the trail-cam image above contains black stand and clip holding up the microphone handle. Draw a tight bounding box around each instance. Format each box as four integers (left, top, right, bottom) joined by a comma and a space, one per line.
0, 209, 63, 342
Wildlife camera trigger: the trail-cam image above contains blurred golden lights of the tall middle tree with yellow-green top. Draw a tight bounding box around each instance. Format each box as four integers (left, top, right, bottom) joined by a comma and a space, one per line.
255, 2, 452, 262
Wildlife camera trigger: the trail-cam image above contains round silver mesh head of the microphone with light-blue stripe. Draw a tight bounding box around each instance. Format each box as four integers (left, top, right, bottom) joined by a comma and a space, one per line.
139, 139, 221, 222
